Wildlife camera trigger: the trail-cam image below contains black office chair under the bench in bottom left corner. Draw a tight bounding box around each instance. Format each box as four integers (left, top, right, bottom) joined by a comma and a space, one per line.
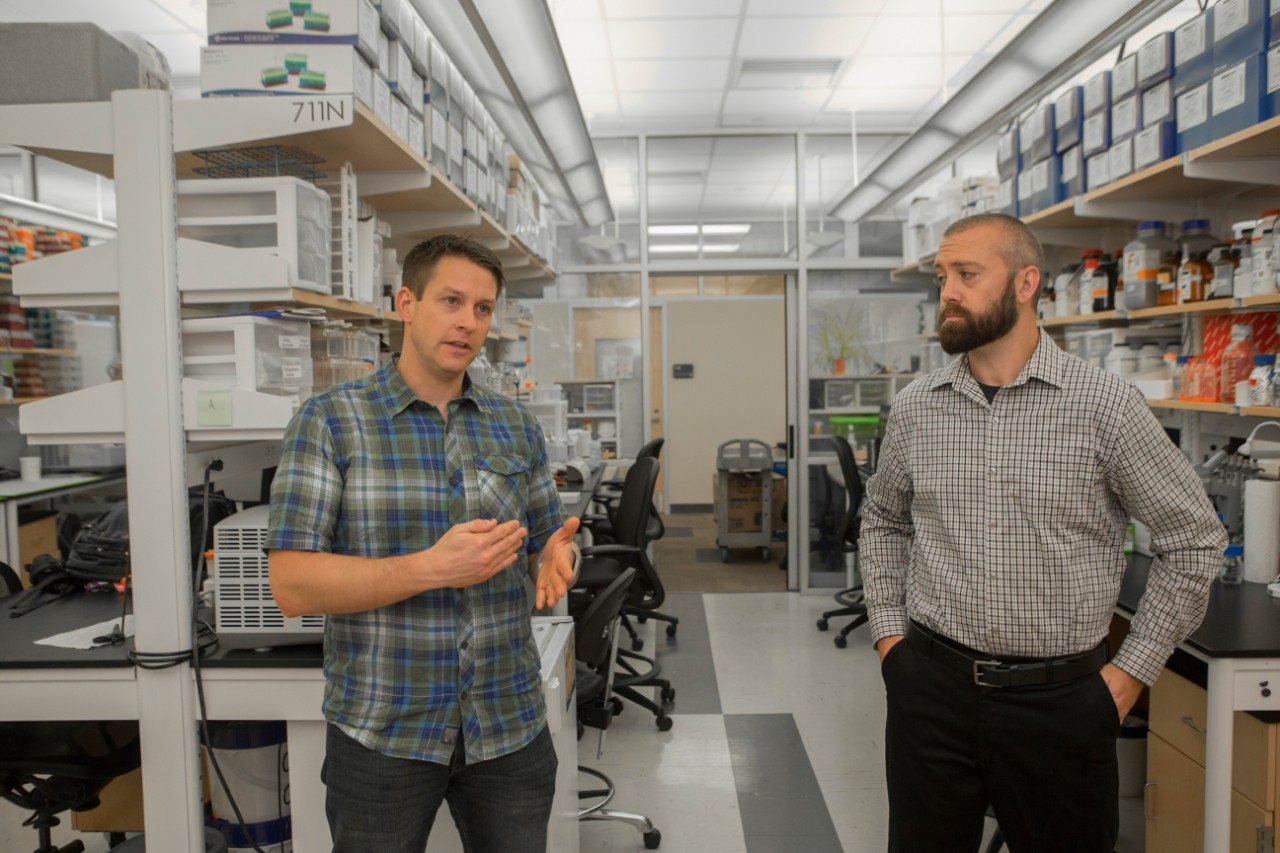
0, 720, 142, 853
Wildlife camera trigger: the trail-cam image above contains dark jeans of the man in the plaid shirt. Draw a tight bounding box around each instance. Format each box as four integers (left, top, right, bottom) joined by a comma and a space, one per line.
320, 725, 557, 853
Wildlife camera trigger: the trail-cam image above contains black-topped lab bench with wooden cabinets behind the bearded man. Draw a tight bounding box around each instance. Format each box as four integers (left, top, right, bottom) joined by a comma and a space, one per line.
1116, 555, 1280, 853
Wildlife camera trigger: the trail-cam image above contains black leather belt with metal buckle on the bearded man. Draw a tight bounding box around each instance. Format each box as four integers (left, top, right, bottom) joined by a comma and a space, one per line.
906, 622, 1110, 686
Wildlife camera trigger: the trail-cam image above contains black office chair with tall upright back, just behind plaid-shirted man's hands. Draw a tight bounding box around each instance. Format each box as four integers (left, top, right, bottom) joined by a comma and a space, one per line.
570, 459, 676, 731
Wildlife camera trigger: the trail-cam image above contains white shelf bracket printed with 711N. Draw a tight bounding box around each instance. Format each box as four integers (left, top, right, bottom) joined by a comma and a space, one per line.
173, 95, 356, 151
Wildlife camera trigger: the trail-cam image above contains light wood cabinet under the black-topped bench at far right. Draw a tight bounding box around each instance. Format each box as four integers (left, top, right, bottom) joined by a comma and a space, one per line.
1146, 670, 1280, 853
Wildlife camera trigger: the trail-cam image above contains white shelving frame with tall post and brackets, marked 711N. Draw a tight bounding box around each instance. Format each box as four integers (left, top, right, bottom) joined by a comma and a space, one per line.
0, 81, 553, 853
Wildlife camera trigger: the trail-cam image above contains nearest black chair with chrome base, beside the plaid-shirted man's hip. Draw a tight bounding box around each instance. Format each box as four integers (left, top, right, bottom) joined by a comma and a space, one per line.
573, 560, 662, 850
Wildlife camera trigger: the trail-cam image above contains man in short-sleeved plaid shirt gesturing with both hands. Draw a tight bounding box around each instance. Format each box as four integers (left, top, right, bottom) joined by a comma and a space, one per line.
268, 236, 579, 853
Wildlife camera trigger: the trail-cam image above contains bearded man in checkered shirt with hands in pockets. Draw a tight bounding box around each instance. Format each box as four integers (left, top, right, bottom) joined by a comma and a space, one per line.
860, 214, 1226, 853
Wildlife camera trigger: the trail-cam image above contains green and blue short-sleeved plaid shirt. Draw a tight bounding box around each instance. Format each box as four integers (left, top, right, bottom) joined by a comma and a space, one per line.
266, 360, 564, 763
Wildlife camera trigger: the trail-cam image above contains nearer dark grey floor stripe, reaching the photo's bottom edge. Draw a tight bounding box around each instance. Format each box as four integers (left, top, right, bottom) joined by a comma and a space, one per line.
724, 713, 842, 853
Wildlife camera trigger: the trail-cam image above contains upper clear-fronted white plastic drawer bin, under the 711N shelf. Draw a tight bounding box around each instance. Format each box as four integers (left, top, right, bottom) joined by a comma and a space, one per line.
178, 177, 333, 293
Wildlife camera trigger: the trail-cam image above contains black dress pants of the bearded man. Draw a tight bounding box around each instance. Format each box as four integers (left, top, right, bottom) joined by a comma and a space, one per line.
881, 640, 1120, 853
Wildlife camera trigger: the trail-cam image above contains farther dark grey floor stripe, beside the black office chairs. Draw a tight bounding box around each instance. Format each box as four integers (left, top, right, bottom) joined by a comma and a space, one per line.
650, 593, 721, 712
